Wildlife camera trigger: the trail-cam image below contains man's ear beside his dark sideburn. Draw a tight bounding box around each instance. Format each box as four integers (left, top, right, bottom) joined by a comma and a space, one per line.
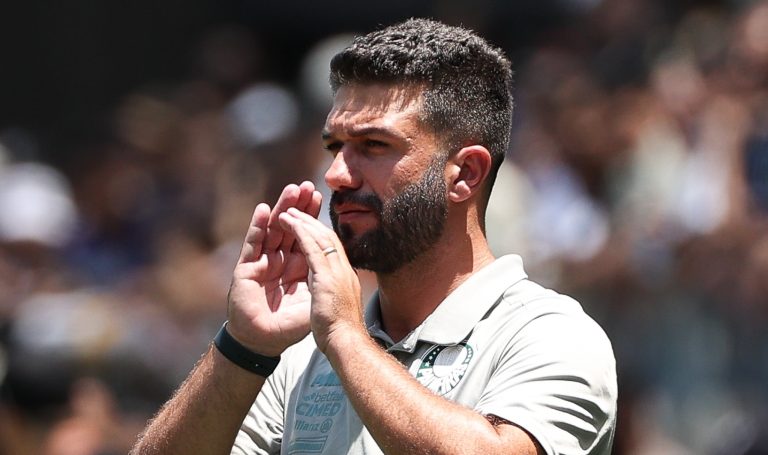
447, 145, 491, 202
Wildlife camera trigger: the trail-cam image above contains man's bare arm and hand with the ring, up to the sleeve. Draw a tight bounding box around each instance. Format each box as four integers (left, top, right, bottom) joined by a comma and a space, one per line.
281, 210, 543, 455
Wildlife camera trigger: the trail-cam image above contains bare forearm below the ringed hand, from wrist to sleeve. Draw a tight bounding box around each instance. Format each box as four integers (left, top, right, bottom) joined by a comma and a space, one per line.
325, 330, 543, 455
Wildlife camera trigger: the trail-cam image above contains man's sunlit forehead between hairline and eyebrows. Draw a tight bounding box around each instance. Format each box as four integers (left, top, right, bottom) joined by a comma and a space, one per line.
325, 84, 422, 131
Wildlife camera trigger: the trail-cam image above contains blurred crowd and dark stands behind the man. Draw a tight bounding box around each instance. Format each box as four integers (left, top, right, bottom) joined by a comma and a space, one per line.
0, 0, 768, 455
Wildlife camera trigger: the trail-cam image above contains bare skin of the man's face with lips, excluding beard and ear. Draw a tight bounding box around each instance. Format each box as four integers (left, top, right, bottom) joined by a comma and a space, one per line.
322, 85, 437, 234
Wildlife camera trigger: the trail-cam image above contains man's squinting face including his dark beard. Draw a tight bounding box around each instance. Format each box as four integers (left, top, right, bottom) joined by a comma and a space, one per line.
323, 85, 448, 273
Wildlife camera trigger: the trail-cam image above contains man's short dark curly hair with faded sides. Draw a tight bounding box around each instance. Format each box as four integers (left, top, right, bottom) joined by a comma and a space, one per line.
330, 19, 512, 199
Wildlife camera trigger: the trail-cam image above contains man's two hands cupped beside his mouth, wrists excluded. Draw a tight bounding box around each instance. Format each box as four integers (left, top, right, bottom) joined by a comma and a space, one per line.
227, 182, 365, 356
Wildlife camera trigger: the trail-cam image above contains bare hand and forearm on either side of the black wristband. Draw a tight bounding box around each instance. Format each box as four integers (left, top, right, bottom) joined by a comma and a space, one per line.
131, 182, 320, 455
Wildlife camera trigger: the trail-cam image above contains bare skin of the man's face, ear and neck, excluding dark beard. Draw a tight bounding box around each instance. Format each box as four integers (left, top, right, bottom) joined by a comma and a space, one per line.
323, 85, 493, 339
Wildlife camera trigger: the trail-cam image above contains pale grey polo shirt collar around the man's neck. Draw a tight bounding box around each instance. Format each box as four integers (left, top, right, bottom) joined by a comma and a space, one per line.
365, 254, 528, 350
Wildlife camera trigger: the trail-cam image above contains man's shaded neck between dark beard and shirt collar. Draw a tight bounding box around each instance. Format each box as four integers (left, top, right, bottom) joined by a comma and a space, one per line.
376, 217, 494, 341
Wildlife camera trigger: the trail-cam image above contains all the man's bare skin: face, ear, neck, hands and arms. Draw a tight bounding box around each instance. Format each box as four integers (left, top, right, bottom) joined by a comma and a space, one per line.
132, 85, 543, 455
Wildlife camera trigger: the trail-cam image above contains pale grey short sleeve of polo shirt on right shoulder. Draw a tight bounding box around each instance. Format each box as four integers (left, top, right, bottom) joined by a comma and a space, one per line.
476, 299, 617, 455
